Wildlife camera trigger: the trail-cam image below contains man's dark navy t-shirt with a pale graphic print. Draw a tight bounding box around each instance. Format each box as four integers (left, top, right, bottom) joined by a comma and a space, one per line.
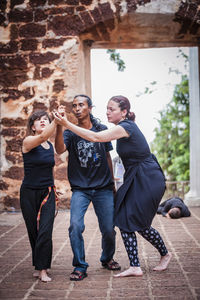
63, 124, 113, 190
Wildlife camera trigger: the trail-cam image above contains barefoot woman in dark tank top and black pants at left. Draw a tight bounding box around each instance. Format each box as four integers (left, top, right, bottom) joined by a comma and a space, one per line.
20, 110, 56, 282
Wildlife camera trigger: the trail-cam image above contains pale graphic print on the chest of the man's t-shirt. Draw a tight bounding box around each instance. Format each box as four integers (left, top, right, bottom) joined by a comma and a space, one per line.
77, 140, 101, 168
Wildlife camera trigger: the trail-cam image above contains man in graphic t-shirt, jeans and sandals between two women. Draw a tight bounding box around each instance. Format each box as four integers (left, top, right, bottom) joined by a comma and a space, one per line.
55, 95, 121, 281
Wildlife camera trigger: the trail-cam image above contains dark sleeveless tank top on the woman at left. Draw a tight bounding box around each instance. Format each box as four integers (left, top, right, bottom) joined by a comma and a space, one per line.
22, 142, 55, 189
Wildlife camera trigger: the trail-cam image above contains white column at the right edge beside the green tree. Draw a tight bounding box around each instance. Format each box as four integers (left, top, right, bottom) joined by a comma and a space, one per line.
185, 47, 200, 206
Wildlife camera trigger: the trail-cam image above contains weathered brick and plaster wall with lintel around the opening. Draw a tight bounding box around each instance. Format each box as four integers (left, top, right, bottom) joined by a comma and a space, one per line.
0, 0, 200, 210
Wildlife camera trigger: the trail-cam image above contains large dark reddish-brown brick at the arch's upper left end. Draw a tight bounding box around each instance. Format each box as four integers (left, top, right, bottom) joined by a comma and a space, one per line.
49, 15, 85, 35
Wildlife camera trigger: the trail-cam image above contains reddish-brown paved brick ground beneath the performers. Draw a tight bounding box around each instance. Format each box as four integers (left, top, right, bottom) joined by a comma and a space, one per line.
0, 207, 200, 300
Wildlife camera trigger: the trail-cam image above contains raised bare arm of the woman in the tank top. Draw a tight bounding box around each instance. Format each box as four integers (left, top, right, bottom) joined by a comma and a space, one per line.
22, 120, 56, 153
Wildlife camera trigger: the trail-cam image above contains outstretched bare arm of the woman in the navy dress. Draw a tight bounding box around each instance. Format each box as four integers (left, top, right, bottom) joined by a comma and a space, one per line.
53, 112, 129, 142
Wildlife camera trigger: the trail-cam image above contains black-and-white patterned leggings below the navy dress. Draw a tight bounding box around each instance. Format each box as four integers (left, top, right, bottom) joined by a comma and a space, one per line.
121, 227, 168, 267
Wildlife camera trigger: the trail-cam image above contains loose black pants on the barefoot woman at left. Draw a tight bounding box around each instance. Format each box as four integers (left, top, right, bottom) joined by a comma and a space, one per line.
20, 186, 55, 270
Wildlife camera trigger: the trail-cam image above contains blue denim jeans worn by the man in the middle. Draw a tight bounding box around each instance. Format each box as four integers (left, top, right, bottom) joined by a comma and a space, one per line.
69, 189, 116, 272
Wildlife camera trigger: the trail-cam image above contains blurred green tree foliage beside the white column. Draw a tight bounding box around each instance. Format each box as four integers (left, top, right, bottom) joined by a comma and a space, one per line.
151, 75, 190, 181
